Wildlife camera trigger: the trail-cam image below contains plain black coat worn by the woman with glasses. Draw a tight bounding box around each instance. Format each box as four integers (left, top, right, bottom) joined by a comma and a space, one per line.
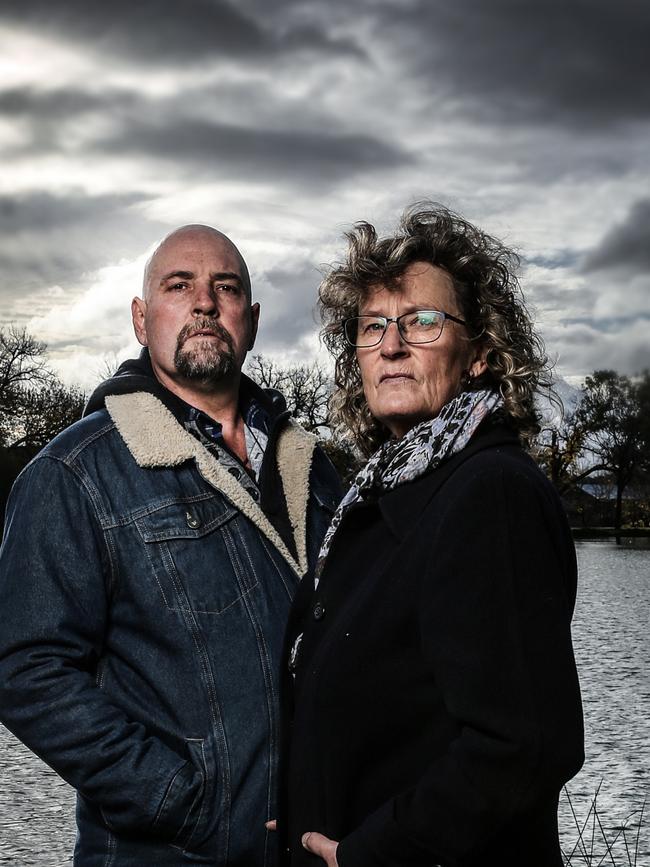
280, 426, 583, 867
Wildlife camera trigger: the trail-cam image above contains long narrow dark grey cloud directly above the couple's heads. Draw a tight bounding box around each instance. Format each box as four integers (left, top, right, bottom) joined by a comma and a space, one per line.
94, 117, 412, 189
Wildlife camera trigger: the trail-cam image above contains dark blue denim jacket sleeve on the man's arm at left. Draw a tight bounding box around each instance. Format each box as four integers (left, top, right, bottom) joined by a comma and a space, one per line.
0, 456, 203, 843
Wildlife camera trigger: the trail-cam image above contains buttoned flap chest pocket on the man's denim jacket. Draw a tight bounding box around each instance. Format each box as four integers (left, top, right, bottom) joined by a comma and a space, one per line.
135, 497, 257, 614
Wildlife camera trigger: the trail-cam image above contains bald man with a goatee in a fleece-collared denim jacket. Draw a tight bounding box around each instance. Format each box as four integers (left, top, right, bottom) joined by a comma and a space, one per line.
0, 226, 339, 867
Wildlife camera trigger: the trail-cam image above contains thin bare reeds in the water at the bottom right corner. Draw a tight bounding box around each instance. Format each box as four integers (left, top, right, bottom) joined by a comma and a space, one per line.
562, 780, 646, 867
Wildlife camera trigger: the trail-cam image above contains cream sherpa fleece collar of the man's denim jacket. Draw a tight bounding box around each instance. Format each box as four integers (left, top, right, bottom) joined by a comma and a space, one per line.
106, 392, 316, 576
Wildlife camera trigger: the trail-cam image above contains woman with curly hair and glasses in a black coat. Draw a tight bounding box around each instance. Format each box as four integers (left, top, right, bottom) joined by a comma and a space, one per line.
283, 206, 583, 867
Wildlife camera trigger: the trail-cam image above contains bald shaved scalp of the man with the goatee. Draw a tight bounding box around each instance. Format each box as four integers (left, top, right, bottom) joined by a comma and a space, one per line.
142, 223, 251, 303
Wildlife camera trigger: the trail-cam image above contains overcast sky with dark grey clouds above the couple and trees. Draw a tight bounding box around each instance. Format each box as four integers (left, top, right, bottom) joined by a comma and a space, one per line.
0, 0, 650, 386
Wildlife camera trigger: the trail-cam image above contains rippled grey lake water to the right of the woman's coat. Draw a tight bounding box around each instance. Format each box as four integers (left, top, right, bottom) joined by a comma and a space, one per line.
560, 539, 650, 865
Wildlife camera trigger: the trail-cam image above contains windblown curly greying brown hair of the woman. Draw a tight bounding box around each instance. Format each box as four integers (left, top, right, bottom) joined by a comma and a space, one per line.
318, 202, 550, 455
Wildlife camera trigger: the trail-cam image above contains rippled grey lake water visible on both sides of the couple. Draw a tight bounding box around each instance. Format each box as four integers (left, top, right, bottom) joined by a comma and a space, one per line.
0, 540, 650, 867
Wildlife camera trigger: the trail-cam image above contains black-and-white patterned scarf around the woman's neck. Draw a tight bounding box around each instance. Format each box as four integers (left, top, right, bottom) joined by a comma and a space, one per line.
314, 389, 503, 589
